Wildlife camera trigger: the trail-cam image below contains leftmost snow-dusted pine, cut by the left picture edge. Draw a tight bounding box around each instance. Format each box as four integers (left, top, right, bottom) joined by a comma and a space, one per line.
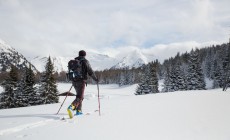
0, 65, 19, 108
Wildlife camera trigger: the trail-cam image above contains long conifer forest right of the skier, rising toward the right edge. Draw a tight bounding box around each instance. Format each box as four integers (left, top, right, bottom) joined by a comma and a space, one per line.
92, 43, 230, 94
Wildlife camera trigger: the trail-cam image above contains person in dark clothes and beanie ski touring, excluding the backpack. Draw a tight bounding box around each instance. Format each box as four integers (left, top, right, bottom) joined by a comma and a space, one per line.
67, 50, 98, 115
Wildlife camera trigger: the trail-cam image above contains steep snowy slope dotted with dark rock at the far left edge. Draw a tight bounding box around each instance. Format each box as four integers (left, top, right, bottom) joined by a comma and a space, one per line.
0, 39, 37, 72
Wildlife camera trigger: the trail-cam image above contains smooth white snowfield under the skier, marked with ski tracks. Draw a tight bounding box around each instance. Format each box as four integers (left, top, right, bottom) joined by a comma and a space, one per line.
0, 83, 230, 140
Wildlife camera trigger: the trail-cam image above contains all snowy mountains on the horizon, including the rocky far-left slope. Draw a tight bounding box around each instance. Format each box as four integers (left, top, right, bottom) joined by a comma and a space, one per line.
0, 40, 155, 72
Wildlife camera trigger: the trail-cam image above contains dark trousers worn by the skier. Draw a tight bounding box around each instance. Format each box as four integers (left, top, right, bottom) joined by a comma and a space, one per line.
72, 80, 85, 110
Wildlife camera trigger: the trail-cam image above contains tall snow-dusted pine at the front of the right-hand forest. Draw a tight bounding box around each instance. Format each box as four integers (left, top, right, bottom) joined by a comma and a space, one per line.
187, 49, 206, 90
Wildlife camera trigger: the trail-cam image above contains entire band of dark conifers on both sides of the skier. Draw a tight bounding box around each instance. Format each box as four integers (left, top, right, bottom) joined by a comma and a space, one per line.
0, 43, 230, 108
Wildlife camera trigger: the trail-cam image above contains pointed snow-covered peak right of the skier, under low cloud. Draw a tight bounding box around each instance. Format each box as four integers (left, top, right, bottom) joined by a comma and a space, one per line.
111, 50, 149, 69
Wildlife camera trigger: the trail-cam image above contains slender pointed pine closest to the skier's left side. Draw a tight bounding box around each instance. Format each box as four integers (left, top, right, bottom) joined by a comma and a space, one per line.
39, 57, 58, 104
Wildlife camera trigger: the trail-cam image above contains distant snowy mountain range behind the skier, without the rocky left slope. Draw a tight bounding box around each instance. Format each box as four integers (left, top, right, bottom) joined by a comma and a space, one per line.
31, 50, 152, 72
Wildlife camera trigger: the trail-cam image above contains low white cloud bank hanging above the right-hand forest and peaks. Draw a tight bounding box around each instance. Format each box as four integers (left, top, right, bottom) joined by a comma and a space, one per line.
97, 41, 218, 63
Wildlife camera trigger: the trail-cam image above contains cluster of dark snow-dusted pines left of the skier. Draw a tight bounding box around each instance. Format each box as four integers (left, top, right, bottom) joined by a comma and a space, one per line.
0, 57, 58, 109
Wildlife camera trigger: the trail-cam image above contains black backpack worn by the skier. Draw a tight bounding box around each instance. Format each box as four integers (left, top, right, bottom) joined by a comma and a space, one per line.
67, 59, 85, 81
